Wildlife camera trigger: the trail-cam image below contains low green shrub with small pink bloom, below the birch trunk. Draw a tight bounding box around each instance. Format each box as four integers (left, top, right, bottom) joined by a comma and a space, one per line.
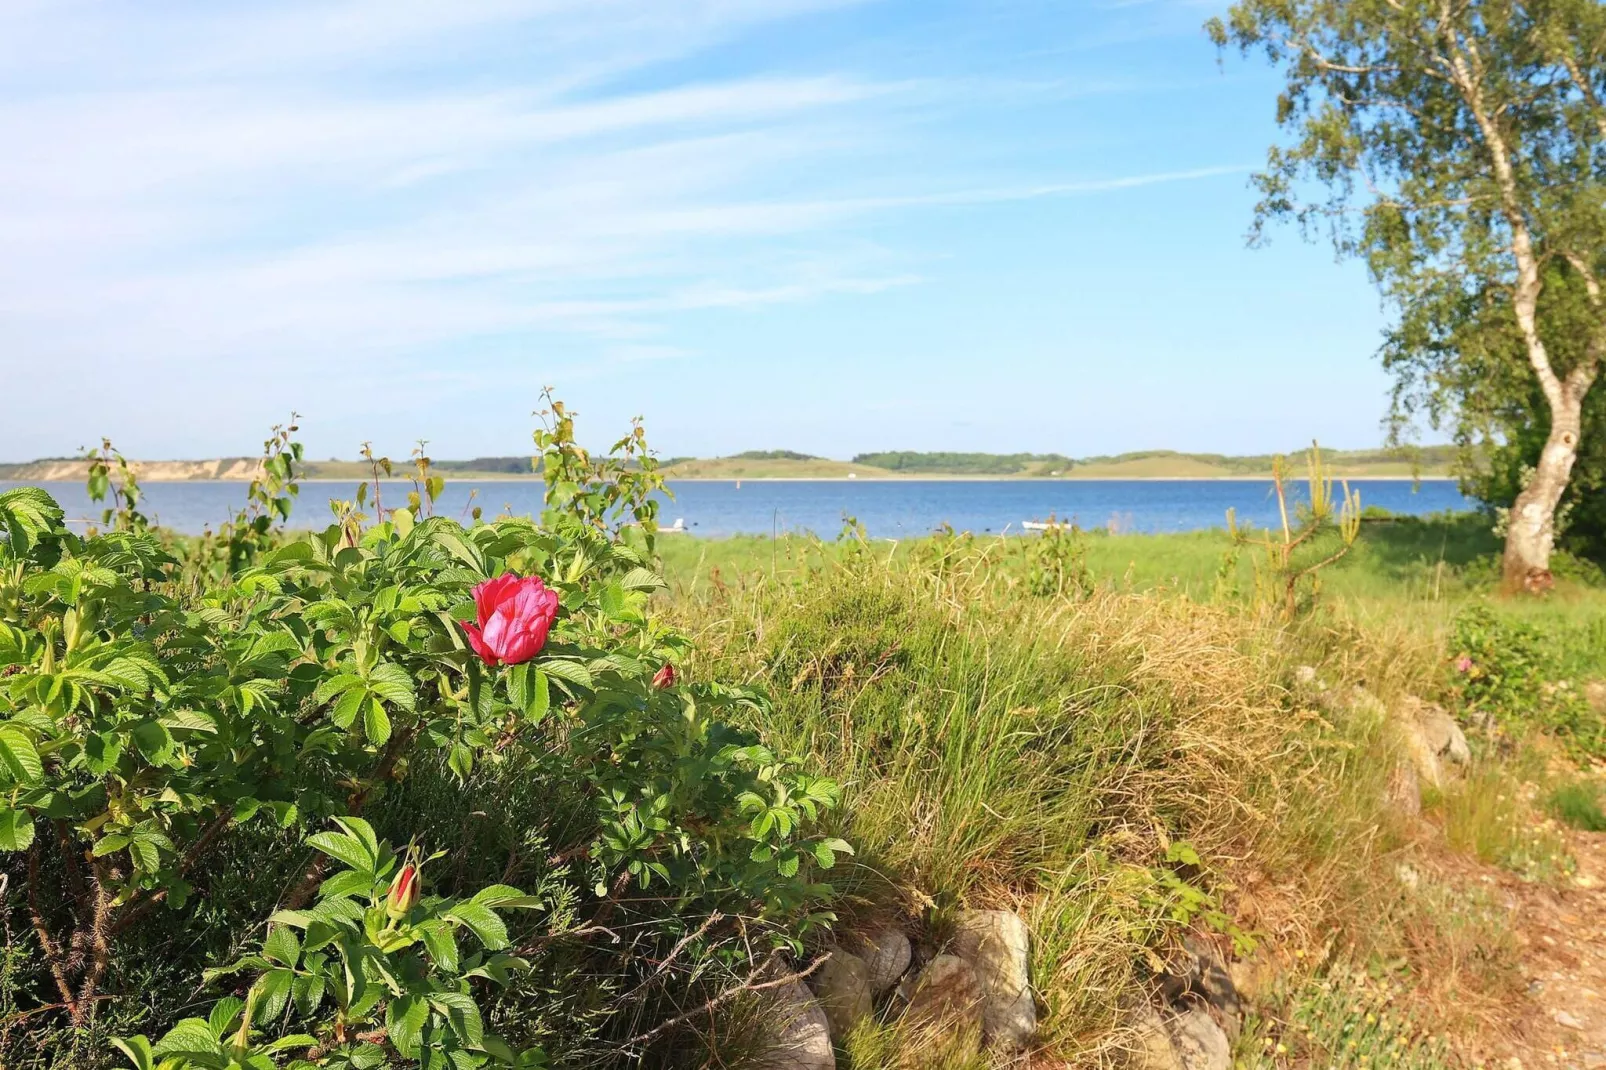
1452, 604, 1606, 755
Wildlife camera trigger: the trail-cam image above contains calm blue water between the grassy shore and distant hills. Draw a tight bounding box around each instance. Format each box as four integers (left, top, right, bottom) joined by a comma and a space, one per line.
0, 479, 1473, 538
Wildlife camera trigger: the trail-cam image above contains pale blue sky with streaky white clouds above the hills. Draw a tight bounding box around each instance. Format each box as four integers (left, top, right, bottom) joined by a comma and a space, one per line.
0, 0, 1388, 459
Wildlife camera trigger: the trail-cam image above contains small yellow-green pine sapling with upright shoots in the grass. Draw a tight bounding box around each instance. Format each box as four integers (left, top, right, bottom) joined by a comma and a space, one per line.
1217, 442, 1360, 620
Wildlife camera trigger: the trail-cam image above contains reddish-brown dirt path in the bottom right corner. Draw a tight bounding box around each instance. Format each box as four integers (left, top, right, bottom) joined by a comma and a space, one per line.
1494, 819, 1606, 1070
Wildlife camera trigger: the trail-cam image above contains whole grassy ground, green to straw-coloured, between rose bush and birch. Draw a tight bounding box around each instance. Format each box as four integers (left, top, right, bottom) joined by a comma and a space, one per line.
662, 517, 1606, 1070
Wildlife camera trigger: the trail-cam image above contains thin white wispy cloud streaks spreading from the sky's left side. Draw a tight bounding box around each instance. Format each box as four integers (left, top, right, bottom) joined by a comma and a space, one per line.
0, 0, 1243, 453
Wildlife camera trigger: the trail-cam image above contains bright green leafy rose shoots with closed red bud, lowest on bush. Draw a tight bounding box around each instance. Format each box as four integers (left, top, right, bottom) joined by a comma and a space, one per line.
112, 818, 546, 1070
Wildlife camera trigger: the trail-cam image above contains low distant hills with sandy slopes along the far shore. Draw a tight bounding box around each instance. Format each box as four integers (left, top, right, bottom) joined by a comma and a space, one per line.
0, 445, 1457, 482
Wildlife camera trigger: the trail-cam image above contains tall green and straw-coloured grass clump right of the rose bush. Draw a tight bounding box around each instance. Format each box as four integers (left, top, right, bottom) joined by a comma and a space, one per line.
671, 541, 1522, 1065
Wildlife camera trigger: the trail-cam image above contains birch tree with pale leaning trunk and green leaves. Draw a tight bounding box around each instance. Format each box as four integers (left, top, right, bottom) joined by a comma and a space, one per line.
1206, 0, 1606, 590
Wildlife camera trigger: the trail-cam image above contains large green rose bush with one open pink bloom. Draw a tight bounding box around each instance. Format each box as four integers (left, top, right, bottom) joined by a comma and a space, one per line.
0, 395, 848, 1067
